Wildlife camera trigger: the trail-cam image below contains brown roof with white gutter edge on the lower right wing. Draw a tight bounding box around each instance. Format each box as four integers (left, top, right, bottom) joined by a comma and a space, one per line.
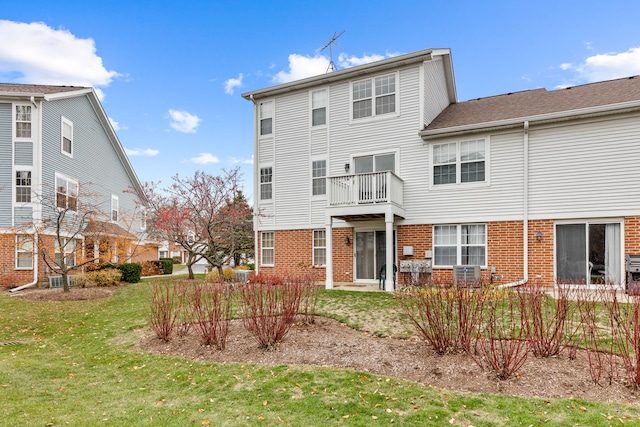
420, 76, 640, 139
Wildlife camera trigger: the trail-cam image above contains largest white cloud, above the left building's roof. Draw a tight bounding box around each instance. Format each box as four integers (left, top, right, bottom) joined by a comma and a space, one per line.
0, 20, 120, 91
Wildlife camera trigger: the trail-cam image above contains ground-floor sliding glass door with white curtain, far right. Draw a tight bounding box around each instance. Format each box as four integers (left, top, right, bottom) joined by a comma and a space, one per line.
556, 222, 623, 285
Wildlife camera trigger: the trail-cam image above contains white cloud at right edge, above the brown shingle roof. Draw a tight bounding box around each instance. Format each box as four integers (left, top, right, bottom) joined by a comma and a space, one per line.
560, 47, 640, 83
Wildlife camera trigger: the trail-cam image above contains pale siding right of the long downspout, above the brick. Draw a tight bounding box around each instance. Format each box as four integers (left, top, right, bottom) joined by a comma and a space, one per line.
529, 114, 640, 219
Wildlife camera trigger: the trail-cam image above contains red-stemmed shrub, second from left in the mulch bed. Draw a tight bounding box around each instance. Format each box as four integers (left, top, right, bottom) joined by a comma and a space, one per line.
191, 282, 233, 350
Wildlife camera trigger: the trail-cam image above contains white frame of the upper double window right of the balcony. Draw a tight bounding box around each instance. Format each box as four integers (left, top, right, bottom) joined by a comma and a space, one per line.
429, 137, 491, 190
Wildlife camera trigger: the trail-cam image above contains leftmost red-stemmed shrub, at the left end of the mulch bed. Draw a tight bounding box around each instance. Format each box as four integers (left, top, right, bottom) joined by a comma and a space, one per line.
148, 281, 182, 342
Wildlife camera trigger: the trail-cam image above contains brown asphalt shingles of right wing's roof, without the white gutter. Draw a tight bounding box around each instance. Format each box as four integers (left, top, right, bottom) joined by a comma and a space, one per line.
425, 76, 640, 130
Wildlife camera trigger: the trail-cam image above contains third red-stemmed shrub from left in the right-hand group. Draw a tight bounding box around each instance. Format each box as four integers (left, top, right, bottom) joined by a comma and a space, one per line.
517, 283, 579, 357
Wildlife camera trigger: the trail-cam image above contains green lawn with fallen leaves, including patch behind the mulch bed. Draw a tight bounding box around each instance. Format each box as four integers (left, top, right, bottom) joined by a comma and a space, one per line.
0, 282, 640, 427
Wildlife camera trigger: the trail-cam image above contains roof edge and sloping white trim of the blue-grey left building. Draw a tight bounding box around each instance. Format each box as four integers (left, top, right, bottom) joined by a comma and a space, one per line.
0, 83, 146, 202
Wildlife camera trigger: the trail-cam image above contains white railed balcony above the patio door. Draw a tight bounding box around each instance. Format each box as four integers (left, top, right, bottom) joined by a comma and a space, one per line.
328, 171, 404, 219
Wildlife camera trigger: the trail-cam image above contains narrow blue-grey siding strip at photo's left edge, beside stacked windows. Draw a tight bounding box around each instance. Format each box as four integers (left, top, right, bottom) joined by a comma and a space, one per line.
0, 103, 13, 227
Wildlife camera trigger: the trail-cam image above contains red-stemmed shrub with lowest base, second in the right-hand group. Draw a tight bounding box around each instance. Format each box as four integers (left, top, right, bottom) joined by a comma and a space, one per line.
474, 294, 531, 379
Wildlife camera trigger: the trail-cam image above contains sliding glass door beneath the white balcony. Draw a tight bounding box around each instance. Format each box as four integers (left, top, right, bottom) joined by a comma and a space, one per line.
355, 230, 395, 280
